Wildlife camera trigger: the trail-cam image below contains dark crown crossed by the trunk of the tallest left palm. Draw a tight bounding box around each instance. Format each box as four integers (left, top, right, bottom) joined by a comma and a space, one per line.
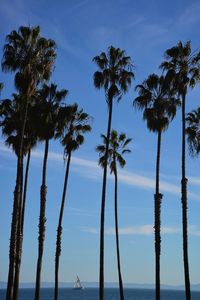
0, 94, 37, 156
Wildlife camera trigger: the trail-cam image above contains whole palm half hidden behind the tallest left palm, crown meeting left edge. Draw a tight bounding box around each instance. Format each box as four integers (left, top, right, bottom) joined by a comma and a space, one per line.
0, 94, 37, 298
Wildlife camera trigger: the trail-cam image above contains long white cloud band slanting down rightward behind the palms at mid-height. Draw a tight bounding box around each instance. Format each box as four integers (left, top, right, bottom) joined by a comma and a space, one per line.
0, 143, 200, 199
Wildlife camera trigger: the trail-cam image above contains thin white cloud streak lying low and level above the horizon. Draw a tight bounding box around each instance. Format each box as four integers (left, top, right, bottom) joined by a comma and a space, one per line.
81, 224, 200, 236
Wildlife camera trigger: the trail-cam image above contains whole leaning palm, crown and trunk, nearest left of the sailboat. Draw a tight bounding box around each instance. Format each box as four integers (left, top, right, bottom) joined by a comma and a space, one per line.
54, 104, 91, 300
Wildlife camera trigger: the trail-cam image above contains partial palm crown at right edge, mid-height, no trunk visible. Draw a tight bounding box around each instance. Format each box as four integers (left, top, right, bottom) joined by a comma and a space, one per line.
186, 108, 200, 156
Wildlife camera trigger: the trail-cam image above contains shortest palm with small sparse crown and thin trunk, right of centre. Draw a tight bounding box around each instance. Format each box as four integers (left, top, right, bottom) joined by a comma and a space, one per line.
96, 130, 131, 300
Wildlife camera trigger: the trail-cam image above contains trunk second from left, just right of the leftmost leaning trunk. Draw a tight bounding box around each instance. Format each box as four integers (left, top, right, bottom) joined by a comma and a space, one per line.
13, 149, 31, 300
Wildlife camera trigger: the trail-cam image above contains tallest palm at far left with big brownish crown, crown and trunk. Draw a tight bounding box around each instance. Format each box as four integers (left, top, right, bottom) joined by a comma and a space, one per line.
2, 26, 56, 300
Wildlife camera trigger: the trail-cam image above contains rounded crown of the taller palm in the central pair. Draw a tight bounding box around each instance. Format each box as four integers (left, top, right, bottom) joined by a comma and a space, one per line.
93, 46, 134, 104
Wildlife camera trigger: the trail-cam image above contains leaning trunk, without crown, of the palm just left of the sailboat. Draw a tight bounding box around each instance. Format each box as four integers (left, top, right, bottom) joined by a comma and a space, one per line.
54, 153, 71, 300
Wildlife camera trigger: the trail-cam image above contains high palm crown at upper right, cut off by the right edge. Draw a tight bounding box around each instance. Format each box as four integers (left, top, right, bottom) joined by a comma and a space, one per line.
160, 41, 200, 95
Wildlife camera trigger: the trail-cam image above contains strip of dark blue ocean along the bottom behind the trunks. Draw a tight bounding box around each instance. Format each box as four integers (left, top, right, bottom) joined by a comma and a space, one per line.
0, 288, 200, 300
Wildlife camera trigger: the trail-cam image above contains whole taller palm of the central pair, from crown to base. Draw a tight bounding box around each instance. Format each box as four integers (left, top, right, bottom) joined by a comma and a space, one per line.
93, 46, 134, 300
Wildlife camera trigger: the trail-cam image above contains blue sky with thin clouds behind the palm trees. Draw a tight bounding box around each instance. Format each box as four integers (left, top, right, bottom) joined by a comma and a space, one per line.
0, 0, 200, 284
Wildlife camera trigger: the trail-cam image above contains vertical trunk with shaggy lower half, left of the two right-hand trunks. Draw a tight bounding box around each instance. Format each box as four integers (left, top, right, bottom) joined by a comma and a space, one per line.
154, 132, 162, 300
